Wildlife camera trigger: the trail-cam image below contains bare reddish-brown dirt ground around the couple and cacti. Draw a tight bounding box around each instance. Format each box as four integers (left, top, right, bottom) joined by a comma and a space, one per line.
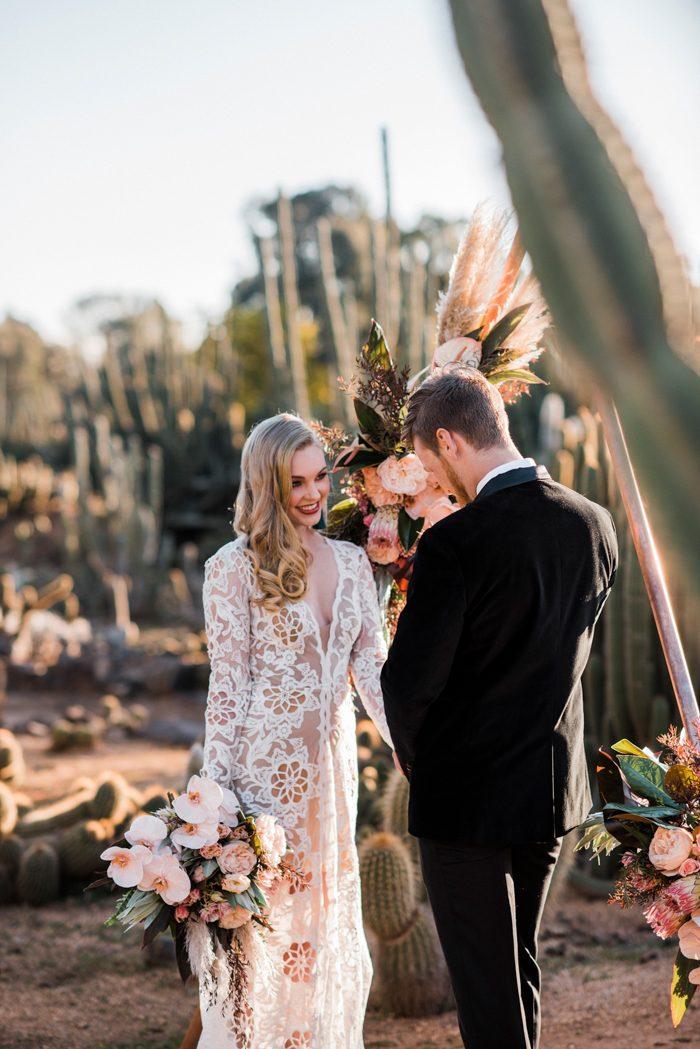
0, 698, 700, 1049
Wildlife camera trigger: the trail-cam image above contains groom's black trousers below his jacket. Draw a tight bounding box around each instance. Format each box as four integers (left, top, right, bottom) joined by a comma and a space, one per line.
420, 838, 561, 1049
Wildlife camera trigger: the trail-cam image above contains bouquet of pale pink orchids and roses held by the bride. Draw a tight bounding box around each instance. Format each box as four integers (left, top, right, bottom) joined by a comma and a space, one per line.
89, 775, 302, 997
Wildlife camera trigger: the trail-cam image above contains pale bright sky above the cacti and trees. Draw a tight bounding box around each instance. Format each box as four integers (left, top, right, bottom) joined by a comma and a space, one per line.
0, 0, 700, 352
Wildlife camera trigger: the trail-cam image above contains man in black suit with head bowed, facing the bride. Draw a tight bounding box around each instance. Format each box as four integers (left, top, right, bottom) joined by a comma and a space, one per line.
382, 367, 617, 1049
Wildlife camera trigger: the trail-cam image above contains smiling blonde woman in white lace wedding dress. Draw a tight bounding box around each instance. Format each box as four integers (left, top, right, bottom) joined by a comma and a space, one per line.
199, 413, 390, 1049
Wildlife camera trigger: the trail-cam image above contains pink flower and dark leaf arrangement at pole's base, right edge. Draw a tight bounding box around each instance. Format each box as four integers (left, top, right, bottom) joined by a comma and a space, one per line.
576, 728, 700, 1027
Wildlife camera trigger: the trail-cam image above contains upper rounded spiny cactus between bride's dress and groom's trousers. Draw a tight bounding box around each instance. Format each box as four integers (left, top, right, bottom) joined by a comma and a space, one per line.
360, 831, 417, 940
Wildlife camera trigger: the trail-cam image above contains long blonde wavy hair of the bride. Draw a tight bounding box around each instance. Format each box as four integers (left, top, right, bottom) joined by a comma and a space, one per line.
233, 412, 321, 612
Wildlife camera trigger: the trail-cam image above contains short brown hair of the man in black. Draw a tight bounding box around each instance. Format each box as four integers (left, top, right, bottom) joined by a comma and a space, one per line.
403, 365, 510, 451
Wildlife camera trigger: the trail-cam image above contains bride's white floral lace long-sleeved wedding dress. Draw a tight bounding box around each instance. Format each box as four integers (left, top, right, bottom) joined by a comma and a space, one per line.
199, 537, 389, 1049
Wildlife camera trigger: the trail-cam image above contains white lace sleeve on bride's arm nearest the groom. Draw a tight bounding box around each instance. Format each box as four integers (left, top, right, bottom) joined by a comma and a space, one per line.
349, 550, 393, 748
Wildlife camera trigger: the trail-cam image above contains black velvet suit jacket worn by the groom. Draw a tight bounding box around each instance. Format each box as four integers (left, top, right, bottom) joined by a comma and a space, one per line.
382, 467, 617, 844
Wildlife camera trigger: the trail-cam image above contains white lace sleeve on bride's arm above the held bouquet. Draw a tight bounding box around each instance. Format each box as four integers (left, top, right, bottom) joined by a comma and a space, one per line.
203, 548, 251, 787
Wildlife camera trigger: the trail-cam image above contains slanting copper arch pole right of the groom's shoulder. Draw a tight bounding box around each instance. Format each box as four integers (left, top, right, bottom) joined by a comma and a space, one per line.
596, 395, 700, 744
